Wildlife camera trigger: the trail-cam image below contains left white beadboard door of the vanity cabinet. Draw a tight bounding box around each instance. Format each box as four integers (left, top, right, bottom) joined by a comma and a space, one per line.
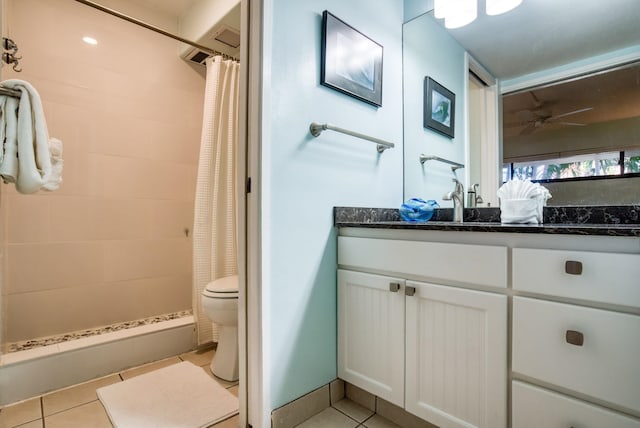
338, 270, 404, 407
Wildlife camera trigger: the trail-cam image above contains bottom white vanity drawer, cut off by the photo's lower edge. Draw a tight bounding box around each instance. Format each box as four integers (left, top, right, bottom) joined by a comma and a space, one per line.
511, 381, 640, 428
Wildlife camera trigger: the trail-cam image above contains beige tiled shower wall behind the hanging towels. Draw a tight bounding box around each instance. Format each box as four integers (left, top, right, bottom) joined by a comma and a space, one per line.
0, 0, 205, 343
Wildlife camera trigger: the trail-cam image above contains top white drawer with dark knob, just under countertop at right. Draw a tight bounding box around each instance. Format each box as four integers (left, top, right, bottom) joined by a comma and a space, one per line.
513, 248, 640, 307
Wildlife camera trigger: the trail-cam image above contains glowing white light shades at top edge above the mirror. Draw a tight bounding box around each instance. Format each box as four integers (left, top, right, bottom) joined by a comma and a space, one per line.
433, 0, 522, 28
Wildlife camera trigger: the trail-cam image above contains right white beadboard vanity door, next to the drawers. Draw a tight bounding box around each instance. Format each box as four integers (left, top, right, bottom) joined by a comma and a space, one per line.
405, 281, 507, 428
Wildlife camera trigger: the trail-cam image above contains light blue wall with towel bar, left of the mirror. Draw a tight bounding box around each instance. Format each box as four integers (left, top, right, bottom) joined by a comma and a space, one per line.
261, 0, 403, 409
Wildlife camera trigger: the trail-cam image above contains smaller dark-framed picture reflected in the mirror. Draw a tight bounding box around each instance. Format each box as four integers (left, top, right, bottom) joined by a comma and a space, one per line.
424, 76, 456, 138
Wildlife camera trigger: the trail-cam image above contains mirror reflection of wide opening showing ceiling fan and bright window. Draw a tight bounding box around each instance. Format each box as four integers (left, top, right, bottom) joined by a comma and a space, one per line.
502, 62, 640, 205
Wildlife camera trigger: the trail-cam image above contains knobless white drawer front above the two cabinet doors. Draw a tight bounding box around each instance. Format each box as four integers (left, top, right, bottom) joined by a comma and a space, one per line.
338, 236, 507, 288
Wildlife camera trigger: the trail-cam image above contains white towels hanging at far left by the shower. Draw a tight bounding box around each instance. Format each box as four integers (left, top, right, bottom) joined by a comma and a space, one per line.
0, 79, 62, 193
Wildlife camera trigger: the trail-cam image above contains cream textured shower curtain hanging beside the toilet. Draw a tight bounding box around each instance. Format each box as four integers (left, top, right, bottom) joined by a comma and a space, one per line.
192, 56, 240, 345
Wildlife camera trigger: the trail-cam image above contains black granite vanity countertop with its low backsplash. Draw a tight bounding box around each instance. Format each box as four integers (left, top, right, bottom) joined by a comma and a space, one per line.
334, 205, 640, 237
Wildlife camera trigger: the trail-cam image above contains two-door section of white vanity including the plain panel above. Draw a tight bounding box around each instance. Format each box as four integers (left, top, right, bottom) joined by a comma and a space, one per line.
338, 237, 507, 428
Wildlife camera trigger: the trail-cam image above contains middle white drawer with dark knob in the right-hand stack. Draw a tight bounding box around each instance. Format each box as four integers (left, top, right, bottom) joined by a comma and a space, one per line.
512, 297, 640, 414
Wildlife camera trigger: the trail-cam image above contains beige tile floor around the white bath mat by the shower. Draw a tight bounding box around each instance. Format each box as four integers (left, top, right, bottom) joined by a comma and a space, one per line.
0, 348, 239, 428
